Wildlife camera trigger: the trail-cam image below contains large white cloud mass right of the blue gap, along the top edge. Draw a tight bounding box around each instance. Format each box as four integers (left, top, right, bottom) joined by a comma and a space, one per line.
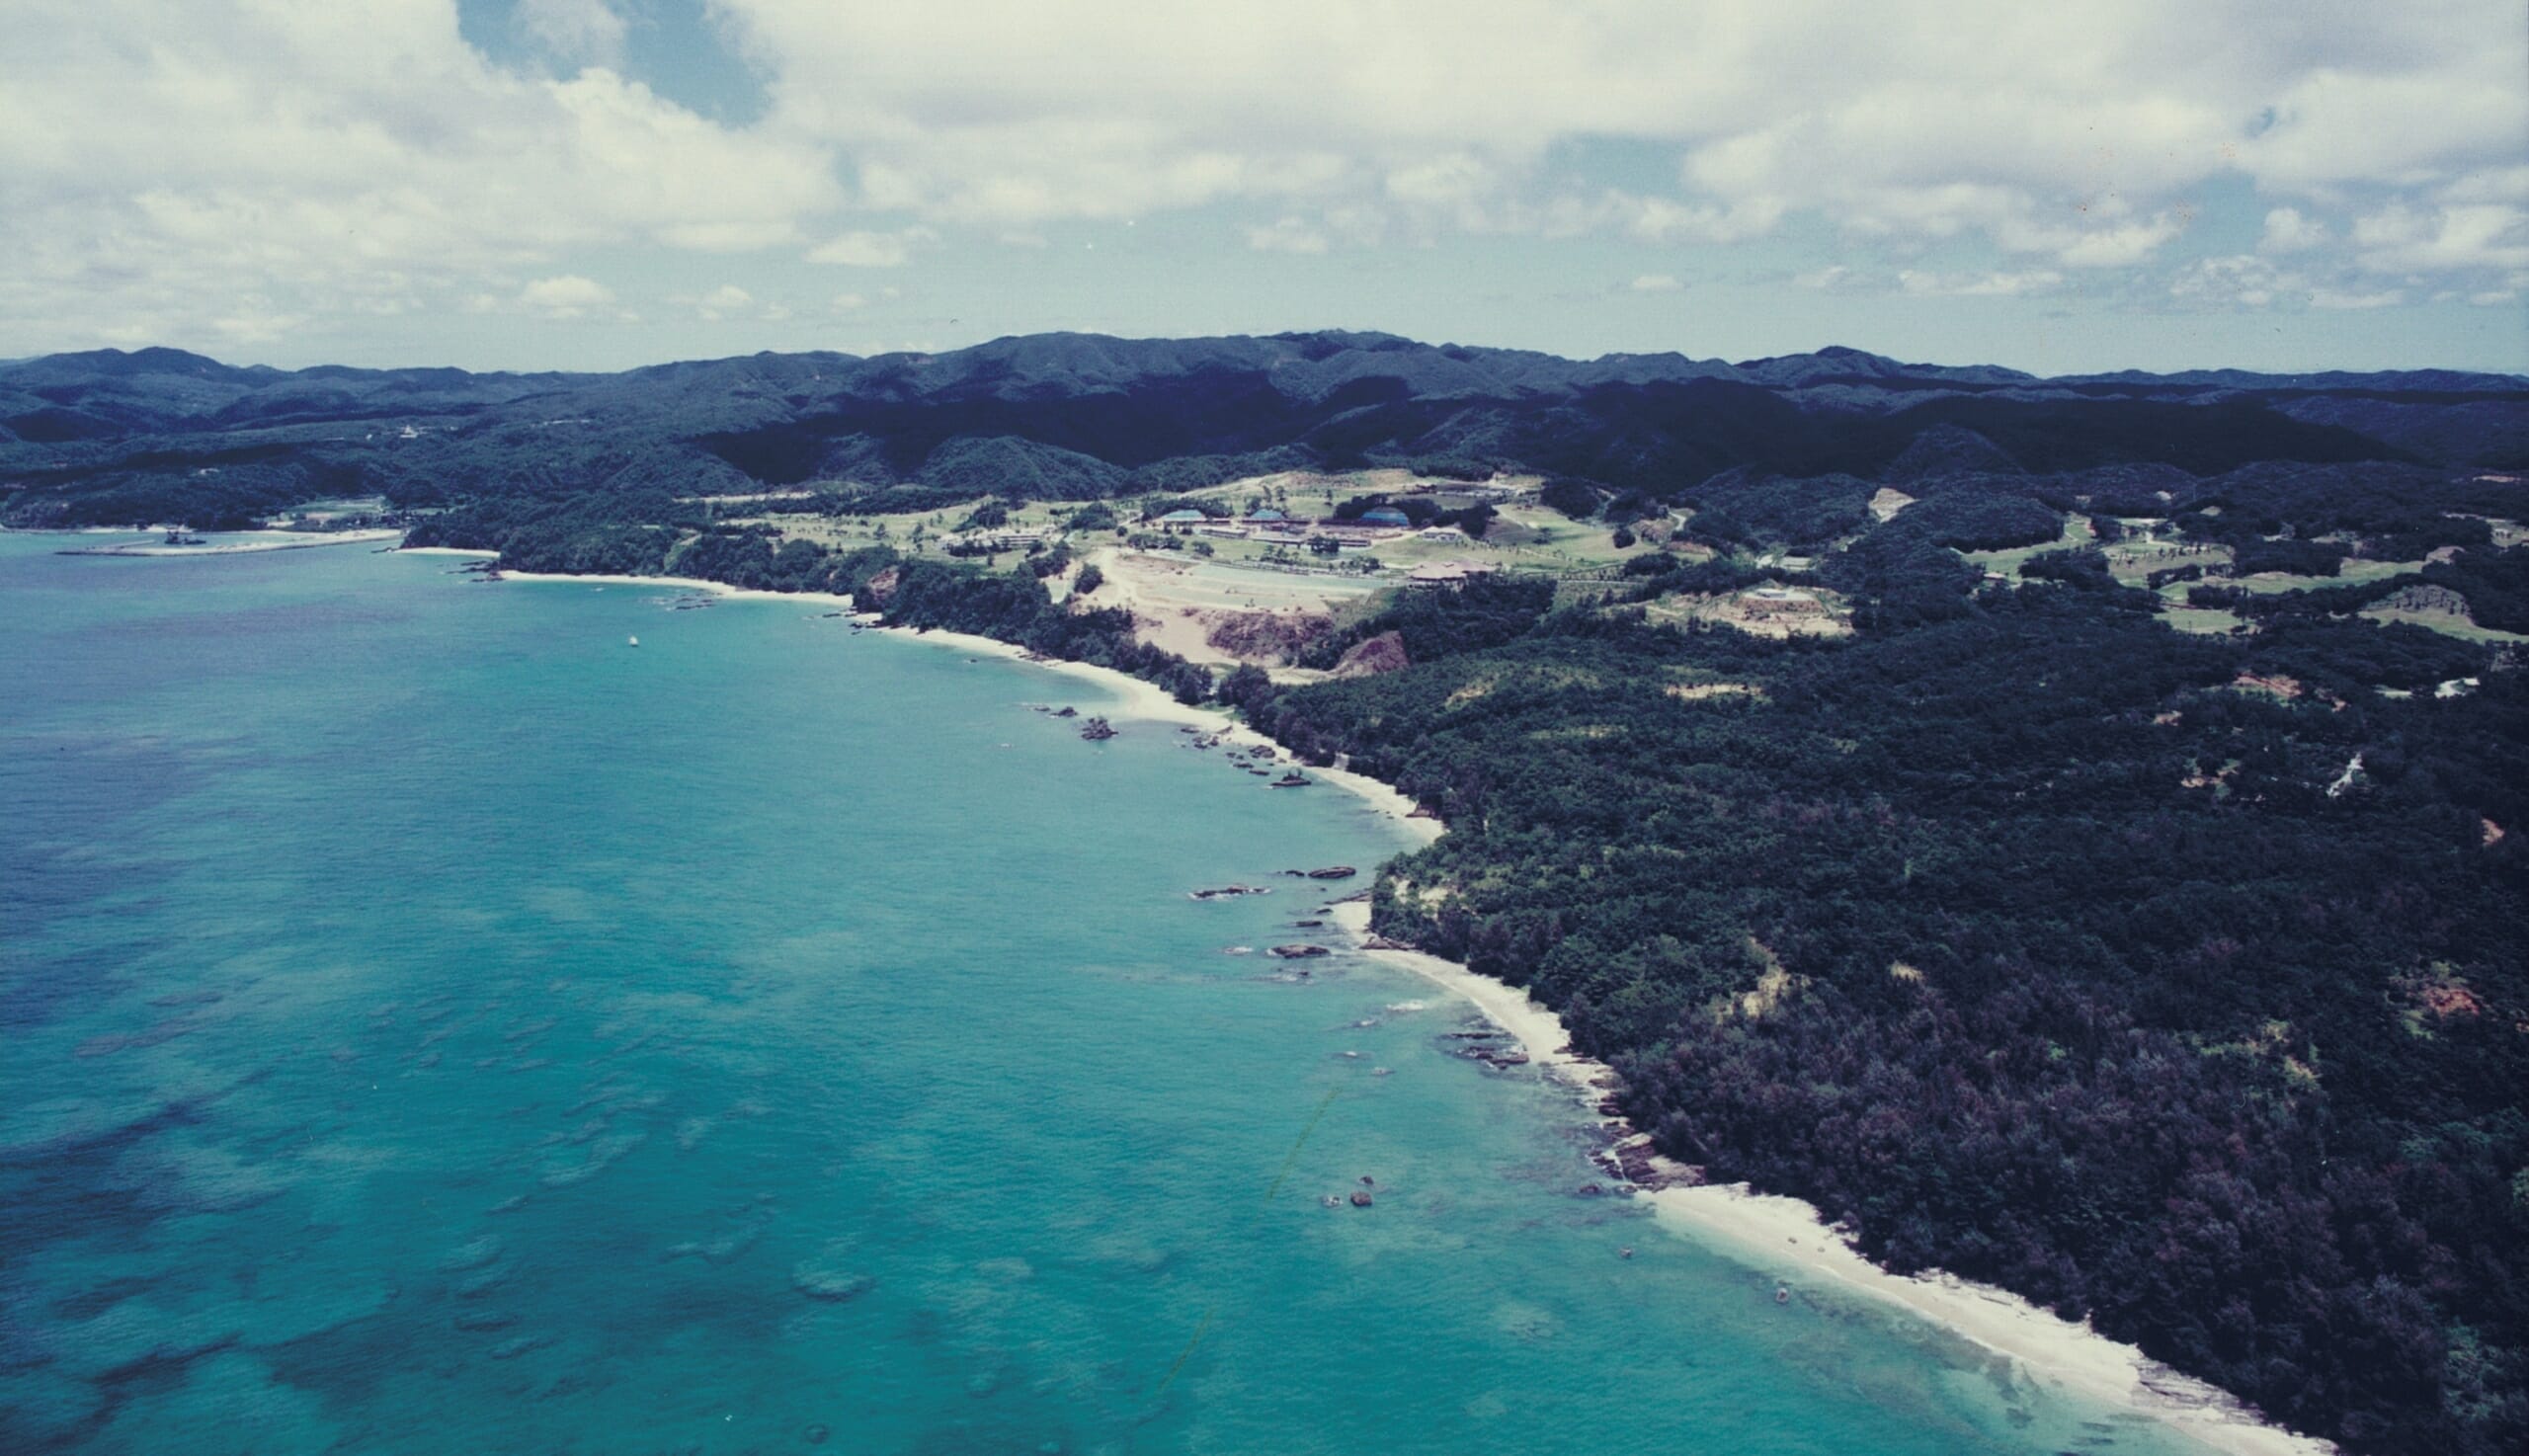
721, 0, 2529, 268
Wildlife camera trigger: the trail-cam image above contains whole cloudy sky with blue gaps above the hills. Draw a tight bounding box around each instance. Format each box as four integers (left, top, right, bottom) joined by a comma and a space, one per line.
0, 0, 2529, 374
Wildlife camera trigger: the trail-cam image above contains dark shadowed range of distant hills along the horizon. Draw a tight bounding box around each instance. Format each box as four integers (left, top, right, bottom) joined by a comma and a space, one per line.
0, 331, 2529, 526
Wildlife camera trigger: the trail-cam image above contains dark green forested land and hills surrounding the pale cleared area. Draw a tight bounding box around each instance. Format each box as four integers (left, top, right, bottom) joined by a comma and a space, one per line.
0, 334, 2529, 1456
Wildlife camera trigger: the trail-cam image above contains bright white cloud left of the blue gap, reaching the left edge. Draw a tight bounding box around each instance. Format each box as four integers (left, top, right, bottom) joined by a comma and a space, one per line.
0, 0, 845, 347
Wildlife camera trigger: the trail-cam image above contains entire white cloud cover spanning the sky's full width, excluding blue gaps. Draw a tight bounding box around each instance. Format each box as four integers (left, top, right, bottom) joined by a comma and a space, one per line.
0, 0, 2529, 347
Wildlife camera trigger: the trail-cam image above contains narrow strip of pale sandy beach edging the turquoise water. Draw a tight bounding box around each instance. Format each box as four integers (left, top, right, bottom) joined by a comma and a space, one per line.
475, 561, 2336, 1456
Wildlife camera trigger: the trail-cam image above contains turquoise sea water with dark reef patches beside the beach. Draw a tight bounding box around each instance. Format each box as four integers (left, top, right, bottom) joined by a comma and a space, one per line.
0, 536, 2215, 1453
